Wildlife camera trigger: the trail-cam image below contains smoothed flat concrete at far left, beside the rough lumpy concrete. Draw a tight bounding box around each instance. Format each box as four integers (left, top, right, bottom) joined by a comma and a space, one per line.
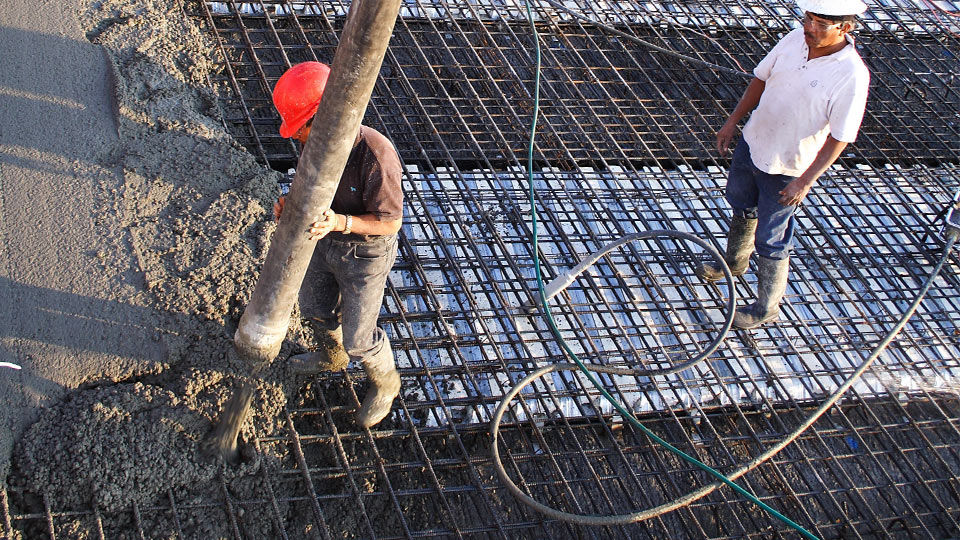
0, 0, 166, 488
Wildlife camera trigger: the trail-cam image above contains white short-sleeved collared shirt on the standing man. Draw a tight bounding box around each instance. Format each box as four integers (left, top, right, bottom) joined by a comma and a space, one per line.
743, 28, 870, 176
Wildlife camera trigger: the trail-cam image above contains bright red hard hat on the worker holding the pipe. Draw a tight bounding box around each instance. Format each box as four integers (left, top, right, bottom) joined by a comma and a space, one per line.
273, 62, 330, 137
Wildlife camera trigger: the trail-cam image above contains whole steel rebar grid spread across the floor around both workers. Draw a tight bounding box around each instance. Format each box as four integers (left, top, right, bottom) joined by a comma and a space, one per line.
0, 0, 960, 538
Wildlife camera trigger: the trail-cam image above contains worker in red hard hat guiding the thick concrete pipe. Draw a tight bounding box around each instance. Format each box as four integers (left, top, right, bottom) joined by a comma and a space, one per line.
273, 62, 403, 427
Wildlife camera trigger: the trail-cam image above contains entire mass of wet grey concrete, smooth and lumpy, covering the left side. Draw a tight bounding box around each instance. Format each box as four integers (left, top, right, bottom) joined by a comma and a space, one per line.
0, 0, 300, 531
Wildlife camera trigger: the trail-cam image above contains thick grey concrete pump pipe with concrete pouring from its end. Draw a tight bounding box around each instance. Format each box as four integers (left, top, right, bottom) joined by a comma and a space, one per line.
204, 0, 400, 464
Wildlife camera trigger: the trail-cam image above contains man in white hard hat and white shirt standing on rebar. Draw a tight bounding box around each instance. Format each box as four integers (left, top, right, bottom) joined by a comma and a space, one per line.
697, 0, 870, 329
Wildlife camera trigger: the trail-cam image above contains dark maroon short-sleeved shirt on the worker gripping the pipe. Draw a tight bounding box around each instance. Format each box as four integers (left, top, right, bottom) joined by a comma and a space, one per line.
330, 126, 403, 221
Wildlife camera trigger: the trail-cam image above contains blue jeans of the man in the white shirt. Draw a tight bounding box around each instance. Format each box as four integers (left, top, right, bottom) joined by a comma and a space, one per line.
726, 137, 797, 260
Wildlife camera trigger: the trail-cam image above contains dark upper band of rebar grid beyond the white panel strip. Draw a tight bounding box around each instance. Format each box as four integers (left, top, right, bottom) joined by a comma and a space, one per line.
199, 2, 960, 168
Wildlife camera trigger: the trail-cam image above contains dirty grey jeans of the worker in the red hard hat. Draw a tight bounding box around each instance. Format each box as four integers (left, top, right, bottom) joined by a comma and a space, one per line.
300, 233, 397, 362
